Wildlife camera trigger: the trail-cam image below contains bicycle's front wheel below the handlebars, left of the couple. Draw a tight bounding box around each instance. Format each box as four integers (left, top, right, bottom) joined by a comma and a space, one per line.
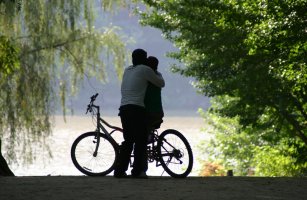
71, 132, 118, 176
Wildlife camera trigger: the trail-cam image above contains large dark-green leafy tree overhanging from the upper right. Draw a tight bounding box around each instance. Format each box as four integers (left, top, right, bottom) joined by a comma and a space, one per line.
140, 0, 307, 175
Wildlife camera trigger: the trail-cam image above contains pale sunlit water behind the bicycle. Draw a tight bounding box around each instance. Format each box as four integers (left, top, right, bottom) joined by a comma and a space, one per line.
11, 116, 208, 176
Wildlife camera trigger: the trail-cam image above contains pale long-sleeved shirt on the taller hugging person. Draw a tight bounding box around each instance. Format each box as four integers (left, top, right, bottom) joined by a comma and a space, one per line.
120, 65, 165, 107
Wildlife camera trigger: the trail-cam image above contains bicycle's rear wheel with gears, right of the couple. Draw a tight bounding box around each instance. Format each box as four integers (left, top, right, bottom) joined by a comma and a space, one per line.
157, 129, 193, 178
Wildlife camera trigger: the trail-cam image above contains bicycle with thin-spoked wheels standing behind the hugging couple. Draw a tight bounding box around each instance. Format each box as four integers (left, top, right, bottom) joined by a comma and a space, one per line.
71, 93, 193, 178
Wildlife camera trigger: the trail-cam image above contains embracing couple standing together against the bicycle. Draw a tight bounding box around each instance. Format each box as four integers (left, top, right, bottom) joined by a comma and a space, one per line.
114, 49, 165, 178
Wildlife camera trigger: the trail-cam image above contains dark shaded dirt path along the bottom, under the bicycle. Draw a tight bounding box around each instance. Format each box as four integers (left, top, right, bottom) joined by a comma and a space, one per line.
0, 176, 307, 200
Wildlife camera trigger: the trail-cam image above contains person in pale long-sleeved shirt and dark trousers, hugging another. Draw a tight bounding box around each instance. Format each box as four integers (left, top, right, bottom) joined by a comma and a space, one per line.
114, 49, 165, 178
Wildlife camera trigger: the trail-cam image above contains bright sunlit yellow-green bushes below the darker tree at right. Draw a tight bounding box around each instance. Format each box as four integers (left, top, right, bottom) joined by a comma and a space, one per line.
200, 98, 307, 176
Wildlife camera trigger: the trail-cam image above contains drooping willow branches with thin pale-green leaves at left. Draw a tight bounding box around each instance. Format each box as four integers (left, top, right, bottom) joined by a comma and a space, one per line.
0, 0, 127, 163
